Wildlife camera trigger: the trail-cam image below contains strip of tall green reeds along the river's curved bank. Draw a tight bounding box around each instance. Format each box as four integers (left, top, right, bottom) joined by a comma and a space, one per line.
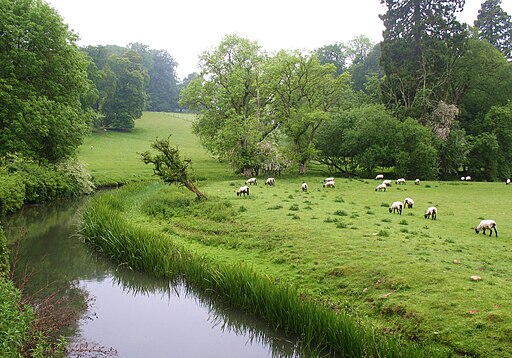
80, 195, 444, 357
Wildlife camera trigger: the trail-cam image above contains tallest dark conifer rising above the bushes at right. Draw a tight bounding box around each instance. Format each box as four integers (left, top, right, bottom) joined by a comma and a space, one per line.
381, 0, 467, 120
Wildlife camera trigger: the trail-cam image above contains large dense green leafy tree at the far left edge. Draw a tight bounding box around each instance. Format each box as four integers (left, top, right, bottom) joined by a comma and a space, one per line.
0, 0, 94, 162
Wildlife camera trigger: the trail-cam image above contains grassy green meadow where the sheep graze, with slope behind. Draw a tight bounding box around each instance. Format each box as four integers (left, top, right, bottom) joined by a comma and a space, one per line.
80, 113, 512, 357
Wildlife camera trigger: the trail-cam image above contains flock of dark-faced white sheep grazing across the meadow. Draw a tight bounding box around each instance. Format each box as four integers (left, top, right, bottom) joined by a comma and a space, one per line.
236, 174, 500, 237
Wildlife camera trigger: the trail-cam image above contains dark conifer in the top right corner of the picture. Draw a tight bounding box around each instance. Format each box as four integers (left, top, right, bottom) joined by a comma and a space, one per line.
475, 0, 512, 60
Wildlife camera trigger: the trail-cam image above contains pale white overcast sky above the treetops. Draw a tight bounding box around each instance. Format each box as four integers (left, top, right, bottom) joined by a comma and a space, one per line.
46, 0, 512, 79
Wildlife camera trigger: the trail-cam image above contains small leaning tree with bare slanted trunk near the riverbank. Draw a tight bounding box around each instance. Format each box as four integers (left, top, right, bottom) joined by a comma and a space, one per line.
140, 136, 206, 199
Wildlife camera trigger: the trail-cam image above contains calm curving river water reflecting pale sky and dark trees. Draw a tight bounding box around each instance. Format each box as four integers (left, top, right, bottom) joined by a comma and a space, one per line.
5, 202, 300, 358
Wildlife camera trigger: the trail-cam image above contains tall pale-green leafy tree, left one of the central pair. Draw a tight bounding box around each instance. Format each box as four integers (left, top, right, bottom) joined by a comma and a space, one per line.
180, 35, 277, 176
